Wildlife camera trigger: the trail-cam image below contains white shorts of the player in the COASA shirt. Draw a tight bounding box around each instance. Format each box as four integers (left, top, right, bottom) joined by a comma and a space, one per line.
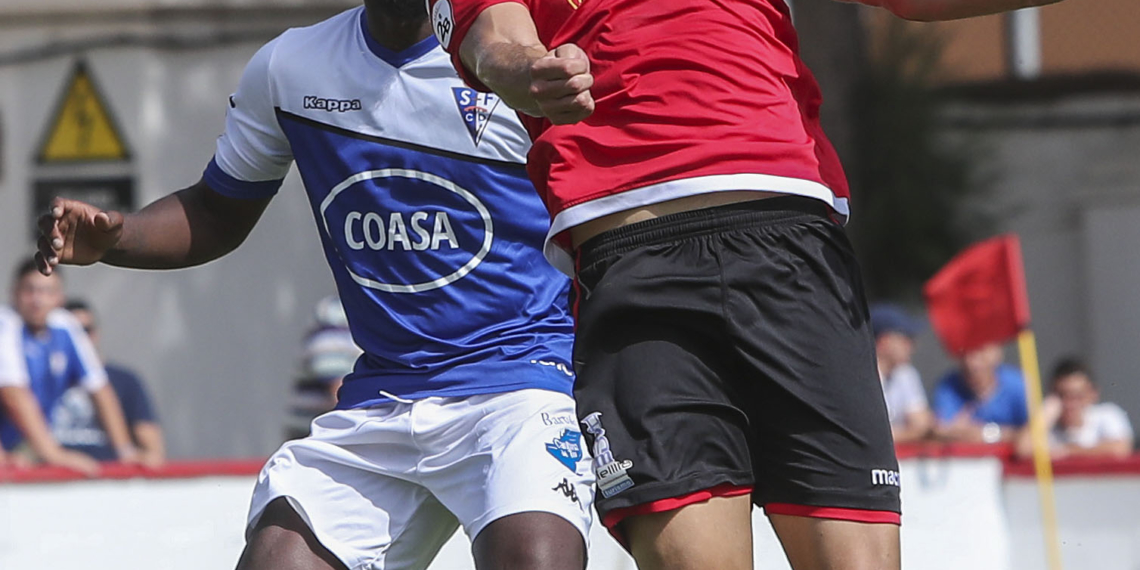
246, 390, 594, 570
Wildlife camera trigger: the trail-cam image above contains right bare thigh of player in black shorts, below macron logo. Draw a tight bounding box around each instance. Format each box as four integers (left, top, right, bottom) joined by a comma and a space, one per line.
768, 514, 901, 570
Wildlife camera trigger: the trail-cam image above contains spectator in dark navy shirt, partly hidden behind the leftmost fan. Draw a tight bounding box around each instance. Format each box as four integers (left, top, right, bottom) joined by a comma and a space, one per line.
51, 300, 166, 467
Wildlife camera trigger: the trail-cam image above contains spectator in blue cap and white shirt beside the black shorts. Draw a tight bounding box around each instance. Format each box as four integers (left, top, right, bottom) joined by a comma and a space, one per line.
871, 304, 934, 443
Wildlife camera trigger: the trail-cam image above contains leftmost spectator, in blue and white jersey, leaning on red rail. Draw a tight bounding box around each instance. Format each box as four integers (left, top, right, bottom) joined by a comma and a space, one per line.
0, 259, 138, 475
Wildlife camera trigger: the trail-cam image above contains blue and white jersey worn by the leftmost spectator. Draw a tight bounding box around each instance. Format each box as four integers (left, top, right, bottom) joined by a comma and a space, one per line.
0, 307, 107, 449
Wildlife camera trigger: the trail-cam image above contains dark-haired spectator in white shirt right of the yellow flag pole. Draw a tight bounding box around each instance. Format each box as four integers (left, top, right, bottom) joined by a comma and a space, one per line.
1018, 358, 1133, 458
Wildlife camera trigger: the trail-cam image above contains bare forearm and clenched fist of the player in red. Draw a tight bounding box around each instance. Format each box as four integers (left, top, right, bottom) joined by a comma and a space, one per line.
459, 2, 594, 124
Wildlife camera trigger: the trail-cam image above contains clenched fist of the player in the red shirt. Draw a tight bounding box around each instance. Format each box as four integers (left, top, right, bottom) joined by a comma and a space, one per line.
530, 43, 594, 124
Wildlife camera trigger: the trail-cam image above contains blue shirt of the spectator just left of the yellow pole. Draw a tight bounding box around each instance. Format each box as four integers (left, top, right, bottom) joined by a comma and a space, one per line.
934, 364, 1029, 428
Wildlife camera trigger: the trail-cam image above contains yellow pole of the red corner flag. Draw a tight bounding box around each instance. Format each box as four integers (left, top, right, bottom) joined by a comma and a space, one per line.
1017, 329, 1061, 570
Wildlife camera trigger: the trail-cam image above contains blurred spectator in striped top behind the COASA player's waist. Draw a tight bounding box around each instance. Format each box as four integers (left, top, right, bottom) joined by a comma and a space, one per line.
285, 295, 363, 439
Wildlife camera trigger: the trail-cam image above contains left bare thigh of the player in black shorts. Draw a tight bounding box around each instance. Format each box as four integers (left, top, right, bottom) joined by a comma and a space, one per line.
620, 495, 752, 570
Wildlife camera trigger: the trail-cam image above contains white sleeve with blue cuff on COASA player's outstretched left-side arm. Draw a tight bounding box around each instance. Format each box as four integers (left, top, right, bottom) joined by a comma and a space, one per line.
202, 38, 293, 200
